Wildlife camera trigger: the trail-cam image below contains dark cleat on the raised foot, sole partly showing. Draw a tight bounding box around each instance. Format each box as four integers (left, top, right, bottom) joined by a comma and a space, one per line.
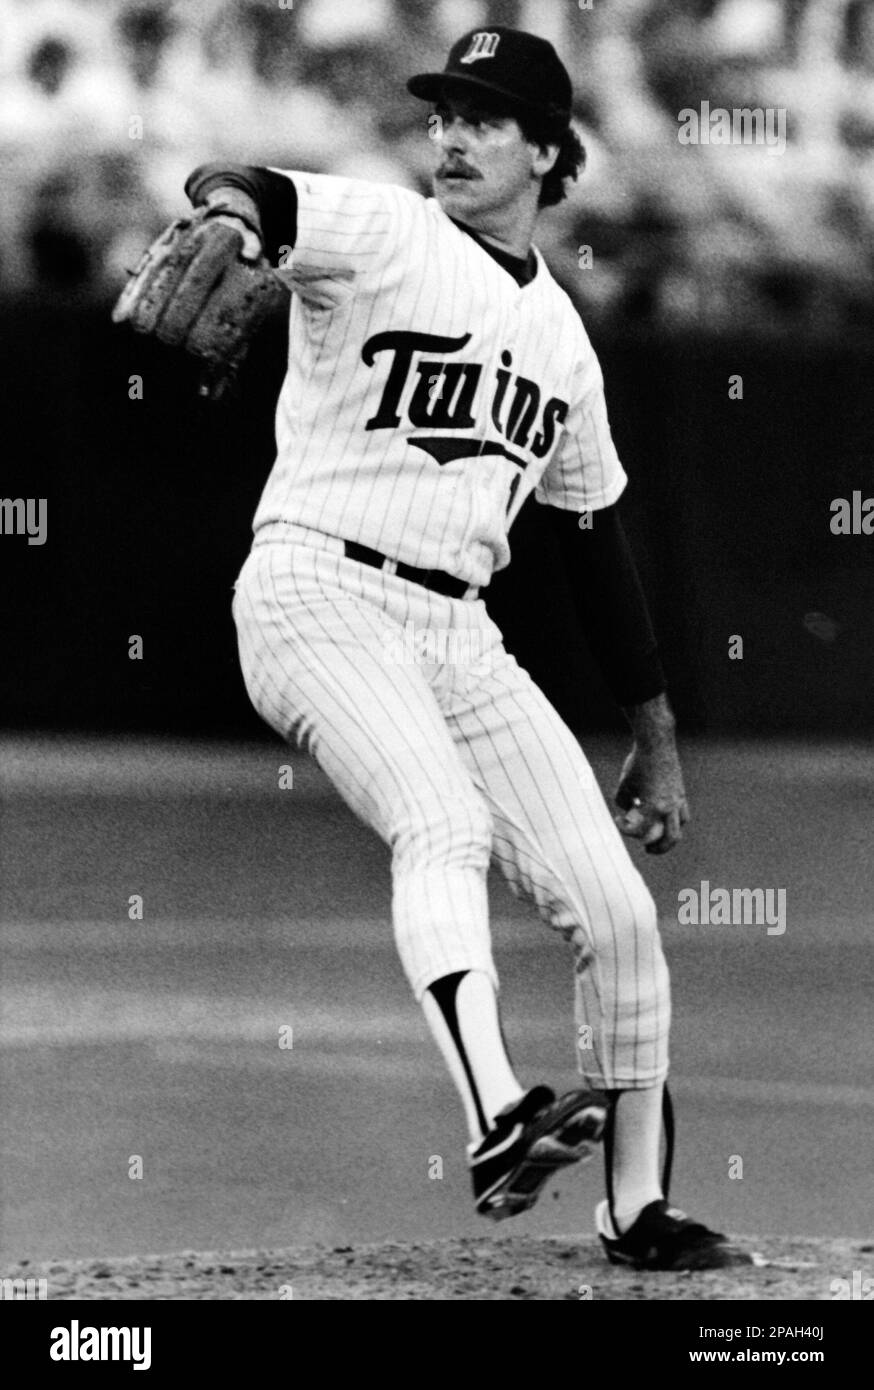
470, 1086, 607, 1220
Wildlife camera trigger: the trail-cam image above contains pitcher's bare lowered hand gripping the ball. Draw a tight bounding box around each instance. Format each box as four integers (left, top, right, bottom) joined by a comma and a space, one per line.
614, 737, 689, 855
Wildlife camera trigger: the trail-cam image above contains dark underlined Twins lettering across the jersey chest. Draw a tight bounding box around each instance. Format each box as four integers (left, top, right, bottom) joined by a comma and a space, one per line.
361, 329, 570, 468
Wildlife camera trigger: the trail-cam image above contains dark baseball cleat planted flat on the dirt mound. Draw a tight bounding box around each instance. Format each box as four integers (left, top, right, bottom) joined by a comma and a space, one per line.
595, 1198, 752, 1270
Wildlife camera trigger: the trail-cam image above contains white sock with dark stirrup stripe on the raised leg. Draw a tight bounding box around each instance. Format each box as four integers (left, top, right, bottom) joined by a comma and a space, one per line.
422, 970, 524, 1143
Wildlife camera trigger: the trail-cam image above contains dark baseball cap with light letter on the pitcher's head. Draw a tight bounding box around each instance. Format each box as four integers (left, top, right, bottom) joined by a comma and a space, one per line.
407, 24, 574, 125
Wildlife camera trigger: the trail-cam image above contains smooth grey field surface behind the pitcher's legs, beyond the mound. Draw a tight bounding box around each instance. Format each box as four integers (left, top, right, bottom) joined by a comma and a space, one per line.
0, 737, 874, 1297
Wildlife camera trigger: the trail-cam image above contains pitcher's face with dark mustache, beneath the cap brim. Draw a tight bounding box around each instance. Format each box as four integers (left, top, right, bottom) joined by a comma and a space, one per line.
434, 85, 538, 227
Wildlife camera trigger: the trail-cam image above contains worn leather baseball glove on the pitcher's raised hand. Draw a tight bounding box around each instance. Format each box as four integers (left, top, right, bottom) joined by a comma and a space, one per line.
113, 207, 288, 400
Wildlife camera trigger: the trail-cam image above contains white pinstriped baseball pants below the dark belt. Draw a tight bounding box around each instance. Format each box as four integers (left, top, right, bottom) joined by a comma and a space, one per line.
233, 525, 670, 1090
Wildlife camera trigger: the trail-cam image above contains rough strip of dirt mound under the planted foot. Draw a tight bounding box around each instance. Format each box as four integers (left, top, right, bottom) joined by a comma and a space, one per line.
8, 1236, 874, 1301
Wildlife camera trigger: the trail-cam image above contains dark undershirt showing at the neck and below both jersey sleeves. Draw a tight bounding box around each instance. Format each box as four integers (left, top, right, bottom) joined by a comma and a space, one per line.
185, 164, 666, 708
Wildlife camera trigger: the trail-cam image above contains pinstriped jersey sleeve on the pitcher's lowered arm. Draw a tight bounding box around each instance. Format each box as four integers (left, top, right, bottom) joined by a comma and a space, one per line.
535, 332, 628, 512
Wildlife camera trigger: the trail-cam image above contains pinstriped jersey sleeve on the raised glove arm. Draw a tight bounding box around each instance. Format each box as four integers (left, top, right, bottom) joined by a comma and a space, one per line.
270, 170, 405, 297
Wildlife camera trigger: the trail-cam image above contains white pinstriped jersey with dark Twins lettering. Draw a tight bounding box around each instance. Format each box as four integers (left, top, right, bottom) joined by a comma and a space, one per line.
254, 170, 627, 585
